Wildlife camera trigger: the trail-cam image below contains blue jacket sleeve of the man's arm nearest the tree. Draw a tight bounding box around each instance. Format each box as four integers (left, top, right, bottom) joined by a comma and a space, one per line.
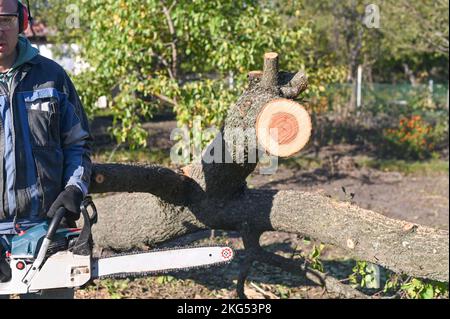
60, 74, 92, 196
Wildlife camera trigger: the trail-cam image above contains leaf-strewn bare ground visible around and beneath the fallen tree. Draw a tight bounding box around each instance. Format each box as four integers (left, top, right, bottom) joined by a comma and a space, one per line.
76, 121, 449, 299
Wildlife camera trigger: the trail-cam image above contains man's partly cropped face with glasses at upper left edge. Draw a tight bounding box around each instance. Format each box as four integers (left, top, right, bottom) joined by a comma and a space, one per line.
0, 0, 19, 60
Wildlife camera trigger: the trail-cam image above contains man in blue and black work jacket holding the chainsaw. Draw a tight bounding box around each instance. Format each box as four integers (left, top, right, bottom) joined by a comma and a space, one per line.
0, 0, 92, 297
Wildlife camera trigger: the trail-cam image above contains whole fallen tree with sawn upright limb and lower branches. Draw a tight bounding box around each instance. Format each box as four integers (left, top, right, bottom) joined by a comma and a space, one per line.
86, 53, 449, 297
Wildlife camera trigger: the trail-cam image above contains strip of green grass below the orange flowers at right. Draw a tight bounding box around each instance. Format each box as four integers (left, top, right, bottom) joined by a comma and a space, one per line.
355, 157, 449, 175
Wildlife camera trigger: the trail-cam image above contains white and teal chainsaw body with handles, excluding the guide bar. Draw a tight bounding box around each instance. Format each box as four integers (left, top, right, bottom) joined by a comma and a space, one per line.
0, 198, 97, 295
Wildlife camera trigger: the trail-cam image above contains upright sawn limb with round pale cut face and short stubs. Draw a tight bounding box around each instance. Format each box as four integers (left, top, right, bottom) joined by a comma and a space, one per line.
182, 53, 311, 198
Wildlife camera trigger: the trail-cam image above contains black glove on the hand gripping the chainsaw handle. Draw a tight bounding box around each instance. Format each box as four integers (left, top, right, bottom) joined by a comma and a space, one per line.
47, 185, 84, 221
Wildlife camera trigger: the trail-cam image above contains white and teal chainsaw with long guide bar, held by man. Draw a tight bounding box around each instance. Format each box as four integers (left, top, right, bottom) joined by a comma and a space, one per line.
0, 197, 234, 295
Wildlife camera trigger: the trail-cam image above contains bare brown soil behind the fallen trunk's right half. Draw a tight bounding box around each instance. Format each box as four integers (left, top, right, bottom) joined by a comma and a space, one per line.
249, 162, 449, 230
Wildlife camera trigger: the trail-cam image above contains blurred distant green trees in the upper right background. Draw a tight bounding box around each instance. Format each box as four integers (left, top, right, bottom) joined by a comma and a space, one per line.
278, 0, 448, 84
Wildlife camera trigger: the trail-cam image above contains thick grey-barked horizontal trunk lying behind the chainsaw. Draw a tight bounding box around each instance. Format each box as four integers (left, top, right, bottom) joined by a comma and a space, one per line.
89, 190, 449, 282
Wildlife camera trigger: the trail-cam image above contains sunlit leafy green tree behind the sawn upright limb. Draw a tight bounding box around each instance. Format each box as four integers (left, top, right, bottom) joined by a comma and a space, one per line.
43, 0, 341, 146
